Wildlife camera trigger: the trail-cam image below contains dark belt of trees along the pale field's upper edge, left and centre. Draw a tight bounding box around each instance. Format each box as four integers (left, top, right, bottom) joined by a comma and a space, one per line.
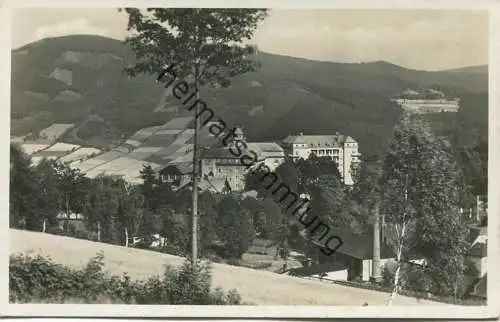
10, 145, 279, 258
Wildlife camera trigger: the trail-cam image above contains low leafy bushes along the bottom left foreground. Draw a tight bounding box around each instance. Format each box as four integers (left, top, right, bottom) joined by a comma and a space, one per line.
9, 254, 241, 305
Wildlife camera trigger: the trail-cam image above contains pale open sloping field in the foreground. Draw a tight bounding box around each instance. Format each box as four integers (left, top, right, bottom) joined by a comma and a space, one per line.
10, 229, 454, 306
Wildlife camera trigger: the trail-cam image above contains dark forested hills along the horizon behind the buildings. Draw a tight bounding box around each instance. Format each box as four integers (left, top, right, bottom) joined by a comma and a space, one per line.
11, 35, 488, 154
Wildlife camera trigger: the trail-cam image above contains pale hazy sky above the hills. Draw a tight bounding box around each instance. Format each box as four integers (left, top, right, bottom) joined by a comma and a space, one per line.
12, 8, 488, 70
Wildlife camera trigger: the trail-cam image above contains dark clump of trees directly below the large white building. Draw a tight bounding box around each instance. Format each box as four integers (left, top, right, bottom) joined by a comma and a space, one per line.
246, 154, 366, 261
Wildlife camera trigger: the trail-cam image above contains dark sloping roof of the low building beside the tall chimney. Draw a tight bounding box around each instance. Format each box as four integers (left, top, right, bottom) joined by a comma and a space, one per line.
313, 227, 395, 259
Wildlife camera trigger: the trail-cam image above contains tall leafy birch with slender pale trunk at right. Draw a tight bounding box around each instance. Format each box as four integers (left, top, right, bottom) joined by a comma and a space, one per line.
373, 115, 470, 304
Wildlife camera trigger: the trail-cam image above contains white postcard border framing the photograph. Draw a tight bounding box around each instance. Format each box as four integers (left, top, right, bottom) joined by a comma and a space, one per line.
0, 0, 500, 319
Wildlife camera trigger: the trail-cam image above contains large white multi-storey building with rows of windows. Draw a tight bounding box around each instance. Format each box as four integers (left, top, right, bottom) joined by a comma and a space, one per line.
283, 133, 361, 185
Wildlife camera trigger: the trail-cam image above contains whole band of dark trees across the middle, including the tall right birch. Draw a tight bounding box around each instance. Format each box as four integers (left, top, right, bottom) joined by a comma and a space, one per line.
10, 112, 484, 296
